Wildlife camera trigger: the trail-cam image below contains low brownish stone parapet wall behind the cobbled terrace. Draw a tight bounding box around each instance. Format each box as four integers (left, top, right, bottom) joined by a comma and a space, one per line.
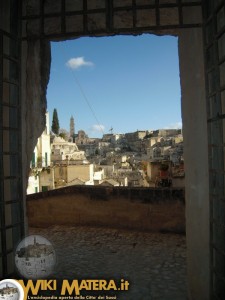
27, 186, 185, 233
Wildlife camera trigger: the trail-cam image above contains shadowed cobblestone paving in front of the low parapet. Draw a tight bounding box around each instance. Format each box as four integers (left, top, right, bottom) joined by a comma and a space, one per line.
30, 226, 188, 300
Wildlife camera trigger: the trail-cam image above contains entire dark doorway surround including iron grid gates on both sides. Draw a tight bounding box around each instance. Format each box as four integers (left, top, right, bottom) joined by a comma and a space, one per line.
0, 0, 225, 300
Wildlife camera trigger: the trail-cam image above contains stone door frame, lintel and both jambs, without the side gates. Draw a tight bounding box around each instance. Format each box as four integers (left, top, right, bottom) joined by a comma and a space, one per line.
2, 0, 216, 300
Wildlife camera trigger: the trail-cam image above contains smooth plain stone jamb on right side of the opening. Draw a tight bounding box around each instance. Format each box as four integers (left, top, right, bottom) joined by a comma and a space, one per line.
179, 29, 210, 300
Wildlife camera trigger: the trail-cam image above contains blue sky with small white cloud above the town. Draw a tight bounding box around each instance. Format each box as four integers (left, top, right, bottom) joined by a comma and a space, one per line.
47, 34, 181, 137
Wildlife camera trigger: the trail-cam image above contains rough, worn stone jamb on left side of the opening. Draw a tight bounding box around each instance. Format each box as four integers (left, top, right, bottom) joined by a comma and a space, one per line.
26, 40, 51, 175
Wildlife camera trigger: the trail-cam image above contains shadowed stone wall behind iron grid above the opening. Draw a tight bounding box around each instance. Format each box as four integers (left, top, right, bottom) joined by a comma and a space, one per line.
24, 0, 201, 39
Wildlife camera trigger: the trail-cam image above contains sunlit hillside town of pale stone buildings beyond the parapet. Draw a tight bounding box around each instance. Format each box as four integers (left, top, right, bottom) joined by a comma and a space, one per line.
27, 113, 185, 194
